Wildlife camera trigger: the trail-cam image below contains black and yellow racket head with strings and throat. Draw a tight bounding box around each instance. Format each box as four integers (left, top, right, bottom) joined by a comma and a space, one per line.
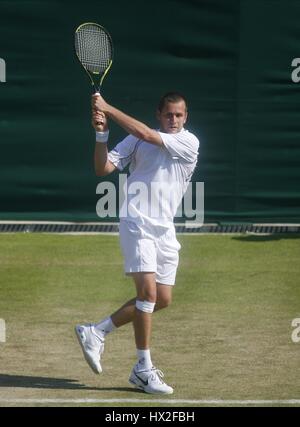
75, 22, 113, 92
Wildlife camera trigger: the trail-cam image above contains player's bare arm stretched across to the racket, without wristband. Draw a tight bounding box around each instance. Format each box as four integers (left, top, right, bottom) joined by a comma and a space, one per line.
92, 94, 163, 145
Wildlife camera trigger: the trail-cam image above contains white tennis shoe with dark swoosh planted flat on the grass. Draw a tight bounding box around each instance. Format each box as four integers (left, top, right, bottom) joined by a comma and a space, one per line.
129, 365, 173, 394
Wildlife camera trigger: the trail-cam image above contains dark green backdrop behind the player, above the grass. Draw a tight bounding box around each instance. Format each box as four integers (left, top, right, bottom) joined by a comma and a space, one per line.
0, 0, 300, 222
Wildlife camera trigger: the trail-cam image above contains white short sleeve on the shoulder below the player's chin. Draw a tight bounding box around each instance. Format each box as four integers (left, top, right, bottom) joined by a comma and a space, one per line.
159, 130, 200, 163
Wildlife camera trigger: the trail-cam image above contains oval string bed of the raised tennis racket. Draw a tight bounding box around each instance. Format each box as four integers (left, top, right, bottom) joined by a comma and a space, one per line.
75, 24, 112, 73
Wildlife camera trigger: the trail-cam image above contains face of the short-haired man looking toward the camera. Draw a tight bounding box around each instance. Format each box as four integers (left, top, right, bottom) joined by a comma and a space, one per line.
157, 101, 187, 133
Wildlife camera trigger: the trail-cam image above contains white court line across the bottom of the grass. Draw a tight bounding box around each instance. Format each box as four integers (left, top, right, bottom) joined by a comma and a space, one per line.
0, 398, 300, 405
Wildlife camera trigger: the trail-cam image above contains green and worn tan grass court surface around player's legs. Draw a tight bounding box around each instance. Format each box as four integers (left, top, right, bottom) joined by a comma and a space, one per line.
0, 234, 300, 406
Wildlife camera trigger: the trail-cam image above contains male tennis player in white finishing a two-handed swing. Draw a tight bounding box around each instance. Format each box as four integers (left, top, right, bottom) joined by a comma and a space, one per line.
75, 92, 199, 394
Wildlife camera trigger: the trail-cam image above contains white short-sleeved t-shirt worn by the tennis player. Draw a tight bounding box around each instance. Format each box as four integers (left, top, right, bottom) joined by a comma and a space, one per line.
108, 129, 199, 229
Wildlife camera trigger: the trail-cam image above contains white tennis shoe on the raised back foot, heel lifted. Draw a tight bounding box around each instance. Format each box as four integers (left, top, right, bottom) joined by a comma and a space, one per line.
75, 324, 104, 374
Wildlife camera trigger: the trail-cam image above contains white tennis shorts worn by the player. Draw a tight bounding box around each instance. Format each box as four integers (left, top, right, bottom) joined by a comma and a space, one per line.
119, 221, 181, 285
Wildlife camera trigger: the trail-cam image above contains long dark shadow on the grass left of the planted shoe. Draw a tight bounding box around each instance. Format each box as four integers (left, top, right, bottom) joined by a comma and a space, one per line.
0, 374, 143, 393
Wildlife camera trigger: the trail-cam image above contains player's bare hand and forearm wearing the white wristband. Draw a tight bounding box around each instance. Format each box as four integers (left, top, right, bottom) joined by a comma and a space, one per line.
92, 107, 116, 176
